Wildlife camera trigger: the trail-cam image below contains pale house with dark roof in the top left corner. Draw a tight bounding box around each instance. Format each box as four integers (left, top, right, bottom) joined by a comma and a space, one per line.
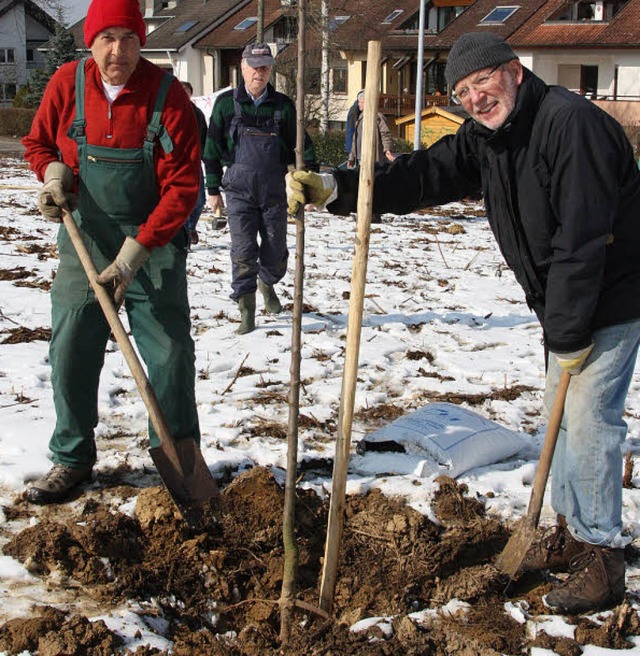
0, 0, 56, 106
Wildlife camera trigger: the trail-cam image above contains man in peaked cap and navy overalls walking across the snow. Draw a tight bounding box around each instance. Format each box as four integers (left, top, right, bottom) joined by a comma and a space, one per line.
204, 43, 317, 335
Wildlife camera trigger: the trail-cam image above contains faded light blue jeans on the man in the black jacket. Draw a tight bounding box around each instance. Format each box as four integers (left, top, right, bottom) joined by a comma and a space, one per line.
544, 320, 640, 548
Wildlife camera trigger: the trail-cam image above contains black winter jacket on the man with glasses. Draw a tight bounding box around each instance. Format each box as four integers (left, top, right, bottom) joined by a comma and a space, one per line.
328, 69, 640, 353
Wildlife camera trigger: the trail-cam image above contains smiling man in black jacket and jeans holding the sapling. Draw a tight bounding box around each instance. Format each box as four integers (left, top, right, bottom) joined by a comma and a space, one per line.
287, 32, 640, 614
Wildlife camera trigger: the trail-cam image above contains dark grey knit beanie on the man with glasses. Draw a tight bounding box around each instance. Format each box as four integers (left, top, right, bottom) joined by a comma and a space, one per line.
444, 32, 517, 89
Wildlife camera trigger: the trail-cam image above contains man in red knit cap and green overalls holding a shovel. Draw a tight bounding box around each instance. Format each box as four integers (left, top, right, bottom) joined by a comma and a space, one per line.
23, 0, 200, 504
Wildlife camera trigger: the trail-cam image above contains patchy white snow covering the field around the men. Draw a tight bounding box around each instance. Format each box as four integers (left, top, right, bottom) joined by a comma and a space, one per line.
0, 159, 640, 656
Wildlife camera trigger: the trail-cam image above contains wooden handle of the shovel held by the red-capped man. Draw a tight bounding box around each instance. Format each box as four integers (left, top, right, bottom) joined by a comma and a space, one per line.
62, 209, 182, 472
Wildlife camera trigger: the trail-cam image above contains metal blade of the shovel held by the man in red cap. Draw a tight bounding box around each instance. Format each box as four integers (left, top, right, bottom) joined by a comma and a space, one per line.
149, 439, 220, 529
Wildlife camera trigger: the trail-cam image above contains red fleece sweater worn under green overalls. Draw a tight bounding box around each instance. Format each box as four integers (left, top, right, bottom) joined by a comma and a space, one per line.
22, 57, 200, 249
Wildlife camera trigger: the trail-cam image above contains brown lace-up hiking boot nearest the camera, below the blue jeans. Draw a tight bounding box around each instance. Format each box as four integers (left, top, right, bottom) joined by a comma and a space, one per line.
542, 544, 624, 615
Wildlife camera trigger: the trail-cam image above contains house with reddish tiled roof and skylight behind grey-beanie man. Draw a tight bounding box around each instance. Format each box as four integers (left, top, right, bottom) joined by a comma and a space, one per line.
425, 0, 640, 101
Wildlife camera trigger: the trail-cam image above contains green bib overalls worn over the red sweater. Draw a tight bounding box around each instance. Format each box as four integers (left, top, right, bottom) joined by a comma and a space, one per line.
49, 62, 200, 466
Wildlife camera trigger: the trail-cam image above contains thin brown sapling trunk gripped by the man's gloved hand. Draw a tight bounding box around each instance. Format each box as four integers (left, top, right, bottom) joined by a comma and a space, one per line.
280, 0, 307, 648
